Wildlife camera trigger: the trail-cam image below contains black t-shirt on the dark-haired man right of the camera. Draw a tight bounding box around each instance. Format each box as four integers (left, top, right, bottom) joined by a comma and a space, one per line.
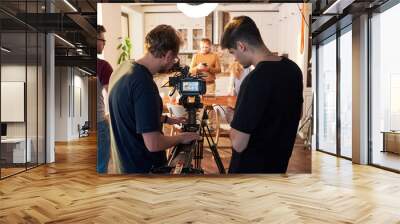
229, 58, 303, 173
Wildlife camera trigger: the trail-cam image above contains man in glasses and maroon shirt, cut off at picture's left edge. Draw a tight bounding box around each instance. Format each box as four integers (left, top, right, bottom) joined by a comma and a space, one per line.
96, 25, 113, 173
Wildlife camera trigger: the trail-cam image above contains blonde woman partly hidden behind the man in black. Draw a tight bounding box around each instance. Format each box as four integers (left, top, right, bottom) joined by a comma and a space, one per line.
229, 61, 254, 96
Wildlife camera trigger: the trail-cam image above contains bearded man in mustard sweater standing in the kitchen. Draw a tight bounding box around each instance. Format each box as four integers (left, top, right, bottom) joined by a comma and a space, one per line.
190, 38, 221, 94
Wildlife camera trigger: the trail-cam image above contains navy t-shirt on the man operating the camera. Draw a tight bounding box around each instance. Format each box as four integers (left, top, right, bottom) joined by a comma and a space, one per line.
109, 63, 166, 173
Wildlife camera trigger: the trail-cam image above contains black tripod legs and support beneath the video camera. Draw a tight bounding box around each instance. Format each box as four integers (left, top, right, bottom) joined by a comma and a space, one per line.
165, 104, 225, 174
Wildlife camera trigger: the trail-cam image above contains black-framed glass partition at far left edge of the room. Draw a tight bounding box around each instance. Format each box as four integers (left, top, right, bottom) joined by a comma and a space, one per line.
0, 1, 46, 178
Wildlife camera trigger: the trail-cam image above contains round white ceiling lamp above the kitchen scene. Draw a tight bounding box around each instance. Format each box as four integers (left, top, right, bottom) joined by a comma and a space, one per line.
176, 3, 218, 18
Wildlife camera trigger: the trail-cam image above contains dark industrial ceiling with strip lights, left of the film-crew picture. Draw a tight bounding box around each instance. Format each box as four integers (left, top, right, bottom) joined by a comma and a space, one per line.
0, 0, 97, 74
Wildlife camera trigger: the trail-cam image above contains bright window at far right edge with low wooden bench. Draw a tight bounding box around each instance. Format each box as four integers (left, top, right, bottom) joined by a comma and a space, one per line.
370, 1, 400, 170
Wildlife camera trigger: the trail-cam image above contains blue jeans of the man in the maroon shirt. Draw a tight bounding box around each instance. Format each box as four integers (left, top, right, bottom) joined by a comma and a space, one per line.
97, 121, 110, 173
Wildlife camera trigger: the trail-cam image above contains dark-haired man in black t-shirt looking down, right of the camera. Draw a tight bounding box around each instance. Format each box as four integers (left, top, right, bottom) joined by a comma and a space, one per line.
221, 16, 303, 173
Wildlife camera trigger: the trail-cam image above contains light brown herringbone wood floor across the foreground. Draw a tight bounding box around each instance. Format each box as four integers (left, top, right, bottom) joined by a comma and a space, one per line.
0, 134, 400, 224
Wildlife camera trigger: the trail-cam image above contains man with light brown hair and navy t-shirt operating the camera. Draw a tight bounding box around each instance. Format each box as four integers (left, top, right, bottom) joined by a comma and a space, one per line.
109, 25, 199, 173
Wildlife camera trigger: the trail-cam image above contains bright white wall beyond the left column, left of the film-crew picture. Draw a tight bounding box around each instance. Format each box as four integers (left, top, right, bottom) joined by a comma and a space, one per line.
55, 67, 89, 141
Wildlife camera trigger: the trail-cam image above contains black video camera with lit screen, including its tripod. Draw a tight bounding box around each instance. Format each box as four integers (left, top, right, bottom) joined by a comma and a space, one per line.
152, 61, 225, 174
